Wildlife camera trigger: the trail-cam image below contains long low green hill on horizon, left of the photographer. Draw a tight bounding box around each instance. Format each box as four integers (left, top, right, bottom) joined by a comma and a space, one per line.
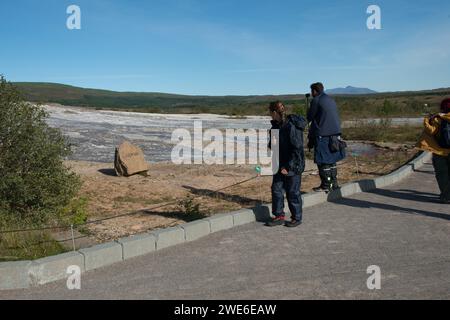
14, 82, 304, 115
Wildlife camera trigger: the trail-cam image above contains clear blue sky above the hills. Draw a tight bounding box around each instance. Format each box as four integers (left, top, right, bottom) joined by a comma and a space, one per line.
0, 0, 450, 95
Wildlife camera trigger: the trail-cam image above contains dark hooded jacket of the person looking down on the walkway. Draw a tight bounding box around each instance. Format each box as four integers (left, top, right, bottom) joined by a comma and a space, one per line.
269, 115, 307, 175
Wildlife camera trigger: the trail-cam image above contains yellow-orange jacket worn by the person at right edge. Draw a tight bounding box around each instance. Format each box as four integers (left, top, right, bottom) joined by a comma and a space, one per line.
416, 113, 450, 157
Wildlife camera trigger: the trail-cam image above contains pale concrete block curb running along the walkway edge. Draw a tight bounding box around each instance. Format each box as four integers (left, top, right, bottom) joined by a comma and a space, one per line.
0, 153, 431, 290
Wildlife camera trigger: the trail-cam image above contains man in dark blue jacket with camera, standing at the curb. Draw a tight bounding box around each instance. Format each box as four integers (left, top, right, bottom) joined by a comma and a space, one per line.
308, 82, 345, 192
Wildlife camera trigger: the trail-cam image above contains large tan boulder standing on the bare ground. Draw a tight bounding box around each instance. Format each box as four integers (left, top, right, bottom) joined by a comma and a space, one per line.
114, 141, 149, 177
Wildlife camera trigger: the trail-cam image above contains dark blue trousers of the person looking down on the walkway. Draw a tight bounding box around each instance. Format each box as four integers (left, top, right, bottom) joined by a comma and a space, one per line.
272, 173, 303, 221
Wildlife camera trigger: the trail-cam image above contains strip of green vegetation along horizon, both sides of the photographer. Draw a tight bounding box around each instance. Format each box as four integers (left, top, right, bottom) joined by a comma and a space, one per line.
15, 83, 450, 120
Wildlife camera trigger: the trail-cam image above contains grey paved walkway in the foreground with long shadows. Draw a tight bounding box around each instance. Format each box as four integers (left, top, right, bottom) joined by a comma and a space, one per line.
0, 164, 450, 299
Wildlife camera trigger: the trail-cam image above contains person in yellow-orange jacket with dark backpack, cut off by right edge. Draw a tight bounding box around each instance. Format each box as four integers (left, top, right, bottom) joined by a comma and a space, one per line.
416, 98, 450, 204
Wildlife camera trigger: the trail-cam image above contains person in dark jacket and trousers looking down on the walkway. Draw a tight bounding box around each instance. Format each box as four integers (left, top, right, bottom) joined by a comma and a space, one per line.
266, 101, 306, 228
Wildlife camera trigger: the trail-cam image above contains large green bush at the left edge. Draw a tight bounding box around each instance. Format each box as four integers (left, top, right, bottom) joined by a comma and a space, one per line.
0, 77, 87, 259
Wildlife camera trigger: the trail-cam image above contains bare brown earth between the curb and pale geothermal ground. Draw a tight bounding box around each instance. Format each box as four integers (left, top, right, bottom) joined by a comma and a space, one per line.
67, 146, 416, 242
